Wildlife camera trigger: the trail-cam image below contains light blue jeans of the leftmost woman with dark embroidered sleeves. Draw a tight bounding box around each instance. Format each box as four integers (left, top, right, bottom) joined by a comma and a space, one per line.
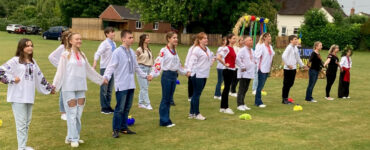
11, 103, 33, 149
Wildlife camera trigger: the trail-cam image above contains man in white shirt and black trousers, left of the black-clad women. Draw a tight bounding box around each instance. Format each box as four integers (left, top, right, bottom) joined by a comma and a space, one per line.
282, 35, 307, 104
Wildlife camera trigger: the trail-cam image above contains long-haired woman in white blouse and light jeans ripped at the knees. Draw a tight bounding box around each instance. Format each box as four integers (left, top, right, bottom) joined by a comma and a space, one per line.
53, 33, 106, 147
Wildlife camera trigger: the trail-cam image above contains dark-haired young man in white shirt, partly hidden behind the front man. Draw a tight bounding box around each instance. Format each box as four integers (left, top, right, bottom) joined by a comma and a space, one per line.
93, 27, 116, 114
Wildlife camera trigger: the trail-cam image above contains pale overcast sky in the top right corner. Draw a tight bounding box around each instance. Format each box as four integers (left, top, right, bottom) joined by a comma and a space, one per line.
338, 0, 370, 15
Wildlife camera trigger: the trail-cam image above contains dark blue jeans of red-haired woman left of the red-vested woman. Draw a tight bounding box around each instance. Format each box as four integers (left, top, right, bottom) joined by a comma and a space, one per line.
190, 75, 207, 115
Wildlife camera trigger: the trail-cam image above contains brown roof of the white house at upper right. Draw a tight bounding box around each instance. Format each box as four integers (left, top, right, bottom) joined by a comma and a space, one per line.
276, 0, 322, 15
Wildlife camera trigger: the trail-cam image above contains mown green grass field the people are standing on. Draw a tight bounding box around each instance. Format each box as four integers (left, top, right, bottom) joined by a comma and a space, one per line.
0, 32, 370, 150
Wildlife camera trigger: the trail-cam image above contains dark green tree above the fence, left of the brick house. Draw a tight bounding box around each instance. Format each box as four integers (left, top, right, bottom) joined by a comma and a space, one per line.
60, 0, 127, 25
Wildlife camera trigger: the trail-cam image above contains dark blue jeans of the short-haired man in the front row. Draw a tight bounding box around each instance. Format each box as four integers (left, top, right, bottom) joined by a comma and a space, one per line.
112, 89, 135, 131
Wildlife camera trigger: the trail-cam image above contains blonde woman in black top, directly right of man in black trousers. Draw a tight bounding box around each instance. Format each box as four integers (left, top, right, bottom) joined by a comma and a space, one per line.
305, 41, 323, 102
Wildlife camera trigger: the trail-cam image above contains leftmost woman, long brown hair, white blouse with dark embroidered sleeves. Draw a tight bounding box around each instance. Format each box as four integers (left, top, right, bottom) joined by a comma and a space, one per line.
0, 39, 54, 149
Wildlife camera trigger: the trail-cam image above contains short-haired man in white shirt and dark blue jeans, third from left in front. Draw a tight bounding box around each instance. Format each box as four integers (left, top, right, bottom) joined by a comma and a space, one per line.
104, 30, 152, 138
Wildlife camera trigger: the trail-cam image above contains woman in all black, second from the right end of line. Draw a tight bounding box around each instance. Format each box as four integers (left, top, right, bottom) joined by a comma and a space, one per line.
324, 44, 339, 100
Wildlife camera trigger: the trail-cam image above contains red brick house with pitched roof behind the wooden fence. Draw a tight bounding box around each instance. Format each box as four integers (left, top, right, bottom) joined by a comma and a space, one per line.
99, 5, 171, 33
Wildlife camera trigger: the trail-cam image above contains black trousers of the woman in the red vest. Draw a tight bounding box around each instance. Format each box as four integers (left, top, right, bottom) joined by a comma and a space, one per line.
221, 69, 236, 109
